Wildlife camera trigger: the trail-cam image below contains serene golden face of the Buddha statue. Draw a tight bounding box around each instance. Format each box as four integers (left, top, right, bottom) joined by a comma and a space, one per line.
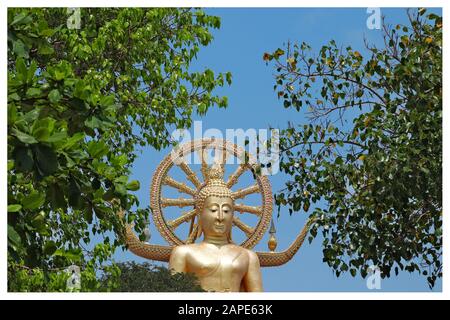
200, 196, 233, 237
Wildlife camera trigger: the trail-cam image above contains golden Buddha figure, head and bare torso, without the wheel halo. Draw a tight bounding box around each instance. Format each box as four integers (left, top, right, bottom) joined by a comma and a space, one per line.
169, 166, 262, 292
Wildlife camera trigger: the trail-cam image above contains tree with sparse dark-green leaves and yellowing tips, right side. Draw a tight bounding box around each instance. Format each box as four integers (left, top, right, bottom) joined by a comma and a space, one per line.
263, 9, 442, 287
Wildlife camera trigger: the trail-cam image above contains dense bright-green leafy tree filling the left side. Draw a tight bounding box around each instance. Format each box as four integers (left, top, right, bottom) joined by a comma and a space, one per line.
8, 8, 231, 291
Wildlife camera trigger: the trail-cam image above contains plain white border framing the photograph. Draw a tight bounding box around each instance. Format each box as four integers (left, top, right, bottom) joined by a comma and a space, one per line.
0, 0, 450, 300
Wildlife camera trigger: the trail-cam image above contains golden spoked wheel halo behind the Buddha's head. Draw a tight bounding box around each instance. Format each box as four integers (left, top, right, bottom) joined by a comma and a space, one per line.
150, 138, 273, 249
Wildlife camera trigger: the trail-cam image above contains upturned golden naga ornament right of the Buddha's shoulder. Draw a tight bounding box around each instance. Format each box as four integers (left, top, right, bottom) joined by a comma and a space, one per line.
256, 219, 315, 267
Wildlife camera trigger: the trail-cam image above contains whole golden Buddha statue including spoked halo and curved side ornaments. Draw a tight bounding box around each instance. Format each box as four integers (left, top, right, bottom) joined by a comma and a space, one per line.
118, 139, 313, 292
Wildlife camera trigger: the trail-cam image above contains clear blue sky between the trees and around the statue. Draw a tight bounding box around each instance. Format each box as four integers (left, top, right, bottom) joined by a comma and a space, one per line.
115, 8, 442, 292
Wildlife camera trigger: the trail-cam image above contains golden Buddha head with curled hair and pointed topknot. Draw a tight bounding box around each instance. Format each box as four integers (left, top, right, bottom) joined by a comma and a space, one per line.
195, 165, 234, 242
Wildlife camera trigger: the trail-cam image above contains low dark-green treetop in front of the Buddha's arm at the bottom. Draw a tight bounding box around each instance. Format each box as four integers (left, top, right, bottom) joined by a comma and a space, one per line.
102, 261, 204, 292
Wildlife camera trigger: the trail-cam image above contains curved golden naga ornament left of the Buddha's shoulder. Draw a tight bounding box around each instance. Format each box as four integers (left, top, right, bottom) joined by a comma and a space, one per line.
118, 211, 173, 262
